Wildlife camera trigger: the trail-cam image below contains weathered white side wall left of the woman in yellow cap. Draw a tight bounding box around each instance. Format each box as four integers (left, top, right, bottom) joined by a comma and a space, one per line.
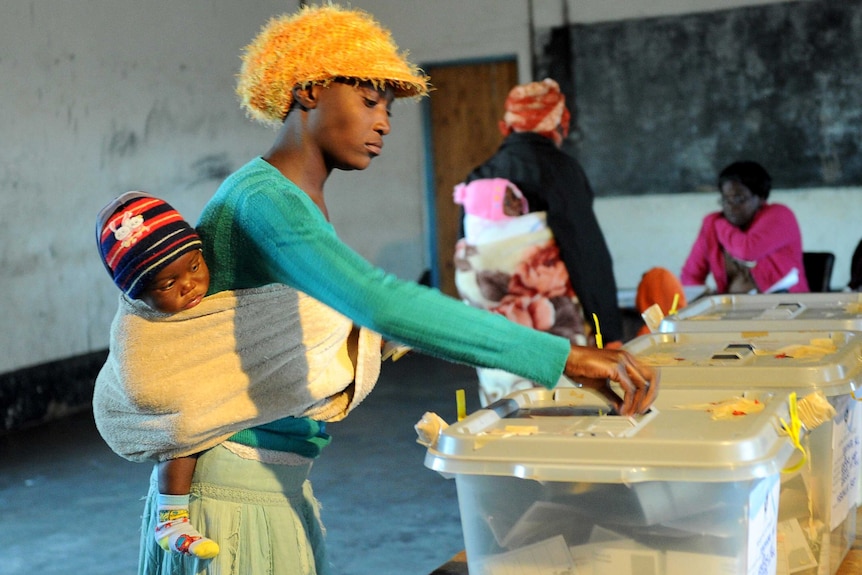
0, 0, 297, 373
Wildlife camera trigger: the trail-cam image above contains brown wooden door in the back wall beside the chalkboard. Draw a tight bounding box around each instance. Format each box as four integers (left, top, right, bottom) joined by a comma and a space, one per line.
425, 57, 518, 297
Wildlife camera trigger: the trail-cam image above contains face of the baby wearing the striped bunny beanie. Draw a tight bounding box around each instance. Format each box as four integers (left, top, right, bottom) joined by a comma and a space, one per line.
140, 250, 210, 313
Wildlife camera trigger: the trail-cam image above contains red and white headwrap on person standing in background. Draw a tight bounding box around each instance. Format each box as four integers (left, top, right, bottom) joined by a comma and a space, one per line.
500, 78, 571, 146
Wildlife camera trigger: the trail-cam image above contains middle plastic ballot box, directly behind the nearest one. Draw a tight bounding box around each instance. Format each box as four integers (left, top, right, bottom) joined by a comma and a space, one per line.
624, 329, 862, 573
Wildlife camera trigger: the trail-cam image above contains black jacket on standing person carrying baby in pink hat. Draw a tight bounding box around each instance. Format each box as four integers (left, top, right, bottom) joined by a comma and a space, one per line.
466, 132, 623, 342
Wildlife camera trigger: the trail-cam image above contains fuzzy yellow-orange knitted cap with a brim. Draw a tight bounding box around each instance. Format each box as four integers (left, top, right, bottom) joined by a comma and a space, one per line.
236, 5, 428, 125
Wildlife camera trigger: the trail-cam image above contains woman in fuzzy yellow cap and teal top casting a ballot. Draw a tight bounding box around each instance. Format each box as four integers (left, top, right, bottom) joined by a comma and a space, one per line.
141, 5, 658, 575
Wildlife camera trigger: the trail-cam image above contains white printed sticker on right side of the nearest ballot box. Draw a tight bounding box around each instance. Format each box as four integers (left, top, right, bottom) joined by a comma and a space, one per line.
747, 474, 780, 575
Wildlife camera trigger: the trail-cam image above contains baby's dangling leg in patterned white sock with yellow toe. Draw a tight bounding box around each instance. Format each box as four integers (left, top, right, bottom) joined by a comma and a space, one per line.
156, 455, 219, 559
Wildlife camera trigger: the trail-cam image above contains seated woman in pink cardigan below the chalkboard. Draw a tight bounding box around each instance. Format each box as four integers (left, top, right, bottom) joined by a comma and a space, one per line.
680, 161, 809, 293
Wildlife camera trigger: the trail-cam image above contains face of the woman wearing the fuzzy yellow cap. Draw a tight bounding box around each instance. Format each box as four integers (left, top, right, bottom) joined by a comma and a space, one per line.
309, 82, 395, 170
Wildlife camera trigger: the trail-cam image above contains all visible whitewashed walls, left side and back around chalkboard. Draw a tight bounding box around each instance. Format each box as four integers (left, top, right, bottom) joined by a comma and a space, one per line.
0, 0, 862, 373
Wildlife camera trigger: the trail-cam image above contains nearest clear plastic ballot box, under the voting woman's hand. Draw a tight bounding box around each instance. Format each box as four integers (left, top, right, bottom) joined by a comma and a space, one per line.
425, 388, 801, 575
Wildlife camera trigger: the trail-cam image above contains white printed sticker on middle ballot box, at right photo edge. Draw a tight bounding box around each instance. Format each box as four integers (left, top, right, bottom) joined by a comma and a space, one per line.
829, 395, 862, 531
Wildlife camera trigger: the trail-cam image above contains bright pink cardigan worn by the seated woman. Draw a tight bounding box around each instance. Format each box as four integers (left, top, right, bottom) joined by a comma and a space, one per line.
680, 203, 809, 293
